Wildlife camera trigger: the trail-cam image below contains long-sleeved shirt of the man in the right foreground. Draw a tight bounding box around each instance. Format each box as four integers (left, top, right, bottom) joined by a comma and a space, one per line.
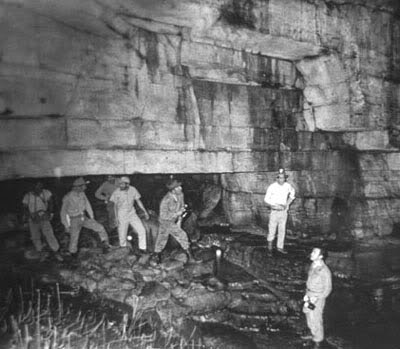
306, 261, 332, 298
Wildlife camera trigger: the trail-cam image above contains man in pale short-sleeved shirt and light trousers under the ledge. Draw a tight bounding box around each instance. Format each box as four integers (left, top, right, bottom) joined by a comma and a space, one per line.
110, 176, 149, 252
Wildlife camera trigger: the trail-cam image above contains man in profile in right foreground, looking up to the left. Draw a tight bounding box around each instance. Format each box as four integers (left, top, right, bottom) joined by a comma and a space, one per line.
303, 247, 332, 349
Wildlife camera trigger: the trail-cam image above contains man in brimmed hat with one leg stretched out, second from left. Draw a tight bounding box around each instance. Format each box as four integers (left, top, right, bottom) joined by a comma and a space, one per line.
60, 177, 110, 254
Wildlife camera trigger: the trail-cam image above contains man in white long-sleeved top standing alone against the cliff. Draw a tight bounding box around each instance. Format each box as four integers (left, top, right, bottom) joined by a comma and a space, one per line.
264, 169, 295, 254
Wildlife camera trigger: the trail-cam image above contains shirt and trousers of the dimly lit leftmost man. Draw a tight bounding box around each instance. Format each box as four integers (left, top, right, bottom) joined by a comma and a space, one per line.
22, 189, 60, 252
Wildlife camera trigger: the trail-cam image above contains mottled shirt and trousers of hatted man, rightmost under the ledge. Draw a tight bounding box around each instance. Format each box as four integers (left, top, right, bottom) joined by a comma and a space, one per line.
154, 192, 189, 253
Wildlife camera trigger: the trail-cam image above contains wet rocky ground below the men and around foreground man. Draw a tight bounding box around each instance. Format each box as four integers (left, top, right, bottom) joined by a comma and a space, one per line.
0, 222, 400, 348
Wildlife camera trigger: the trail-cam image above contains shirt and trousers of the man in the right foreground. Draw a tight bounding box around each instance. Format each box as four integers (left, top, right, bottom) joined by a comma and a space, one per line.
303, 261, 332, 343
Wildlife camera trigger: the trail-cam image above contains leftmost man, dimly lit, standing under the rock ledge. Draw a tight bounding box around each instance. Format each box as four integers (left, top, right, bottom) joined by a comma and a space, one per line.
22, 182, 62, 261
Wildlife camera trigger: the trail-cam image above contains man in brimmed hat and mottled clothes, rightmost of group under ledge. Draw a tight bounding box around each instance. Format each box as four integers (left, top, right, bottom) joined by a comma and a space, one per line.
154, 178, 197, 262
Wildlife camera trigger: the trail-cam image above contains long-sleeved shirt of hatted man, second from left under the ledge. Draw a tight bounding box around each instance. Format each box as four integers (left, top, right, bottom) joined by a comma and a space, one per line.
60, 190, 94, 226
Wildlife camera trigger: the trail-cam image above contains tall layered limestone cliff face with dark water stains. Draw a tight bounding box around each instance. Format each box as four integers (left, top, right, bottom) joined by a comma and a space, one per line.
0, 0, 400, 236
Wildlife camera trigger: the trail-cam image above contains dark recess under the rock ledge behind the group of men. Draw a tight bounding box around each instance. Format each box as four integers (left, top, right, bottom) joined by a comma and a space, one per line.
0, 174, 224, 246
